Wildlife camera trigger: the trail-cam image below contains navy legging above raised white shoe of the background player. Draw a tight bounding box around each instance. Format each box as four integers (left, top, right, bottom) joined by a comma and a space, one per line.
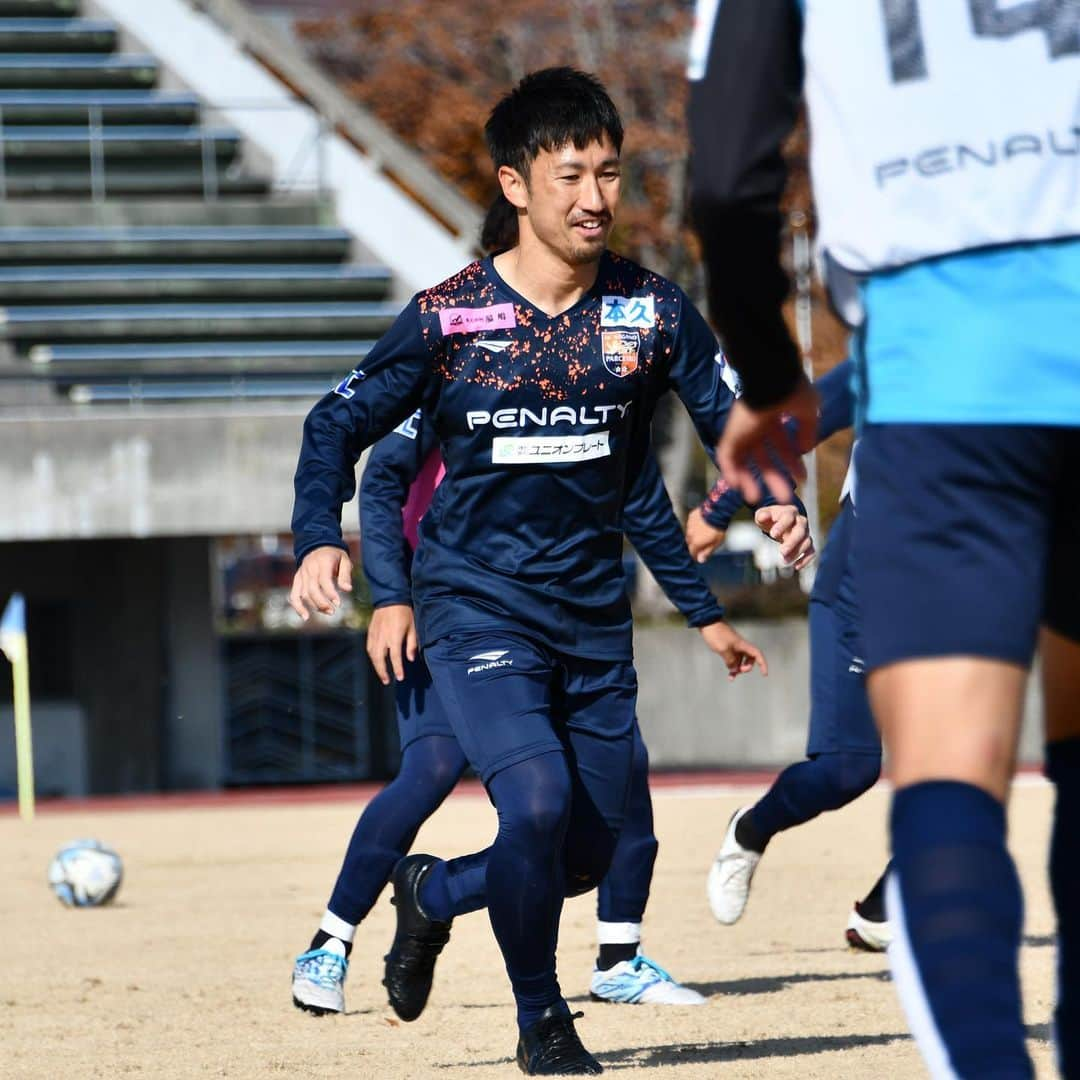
737, 752, 881, 851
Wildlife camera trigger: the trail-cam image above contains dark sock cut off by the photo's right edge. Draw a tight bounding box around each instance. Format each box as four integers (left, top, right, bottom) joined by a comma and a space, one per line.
1047, 738, 1080, 1077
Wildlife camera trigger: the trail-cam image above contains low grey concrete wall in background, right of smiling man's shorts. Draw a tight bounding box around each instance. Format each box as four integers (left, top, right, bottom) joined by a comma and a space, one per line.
634, 619, 1042, 769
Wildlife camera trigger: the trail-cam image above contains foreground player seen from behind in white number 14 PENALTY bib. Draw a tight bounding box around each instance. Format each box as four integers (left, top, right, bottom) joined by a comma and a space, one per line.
690, 0, 1080, 1080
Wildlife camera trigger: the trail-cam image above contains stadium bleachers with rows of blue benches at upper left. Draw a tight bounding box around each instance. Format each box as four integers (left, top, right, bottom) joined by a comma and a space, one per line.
0, 0, 397, 406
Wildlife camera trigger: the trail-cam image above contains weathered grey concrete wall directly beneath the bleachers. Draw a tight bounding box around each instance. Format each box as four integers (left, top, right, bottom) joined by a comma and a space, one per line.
0, 402, 355, 541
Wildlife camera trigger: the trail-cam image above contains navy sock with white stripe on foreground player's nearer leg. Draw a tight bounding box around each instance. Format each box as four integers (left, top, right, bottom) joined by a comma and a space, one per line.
887, 781, 1034, 1080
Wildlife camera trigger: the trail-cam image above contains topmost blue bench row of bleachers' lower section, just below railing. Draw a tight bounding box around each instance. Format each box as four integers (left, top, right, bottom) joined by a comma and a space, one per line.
0, 226, 352, 266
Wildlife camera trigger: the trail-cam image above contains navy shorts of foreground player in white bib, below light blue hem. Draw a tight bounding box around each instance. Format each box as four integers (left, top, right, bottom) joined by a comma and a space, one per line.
855, 419, 1080, 670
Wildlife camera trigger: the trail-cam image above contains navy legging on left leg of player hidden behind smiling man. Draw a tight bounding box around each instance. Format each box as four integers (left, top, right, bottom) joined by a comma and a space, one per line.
327, 735, 465, 926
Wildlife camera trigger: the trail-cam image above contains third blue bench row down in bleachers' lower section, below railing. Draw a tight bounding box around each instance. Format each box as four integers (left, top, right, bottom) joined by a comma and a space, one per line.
0, 302, 400, 349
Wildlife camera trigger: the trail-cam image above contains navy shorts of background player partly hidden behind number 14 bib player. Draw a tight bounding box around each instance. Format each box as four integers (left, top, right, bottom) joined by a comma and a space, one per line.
807, 499, 881, 757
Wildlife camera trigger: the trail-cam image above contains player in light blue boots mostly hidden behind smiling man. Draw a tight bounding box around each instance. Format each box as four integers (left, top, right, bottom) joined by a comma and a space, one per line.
293, 403, 812, 1014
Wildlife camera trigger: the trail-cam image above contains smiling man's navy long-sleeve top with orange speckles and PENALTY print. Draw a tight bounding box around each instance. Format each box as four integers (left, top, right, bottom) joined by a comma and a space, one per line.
293, 253, 734, 660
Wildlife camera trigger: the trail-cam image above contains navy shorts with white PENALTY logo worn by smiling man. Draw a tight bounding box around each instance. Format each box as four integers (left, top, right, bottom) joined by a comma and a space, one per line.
424, 630, 637, 794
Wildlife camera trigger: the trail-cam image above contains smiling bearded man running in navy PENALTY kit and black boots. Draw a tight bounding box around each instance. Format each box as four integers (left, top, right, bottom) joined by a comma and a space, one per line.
293, 68, 807, 1075
